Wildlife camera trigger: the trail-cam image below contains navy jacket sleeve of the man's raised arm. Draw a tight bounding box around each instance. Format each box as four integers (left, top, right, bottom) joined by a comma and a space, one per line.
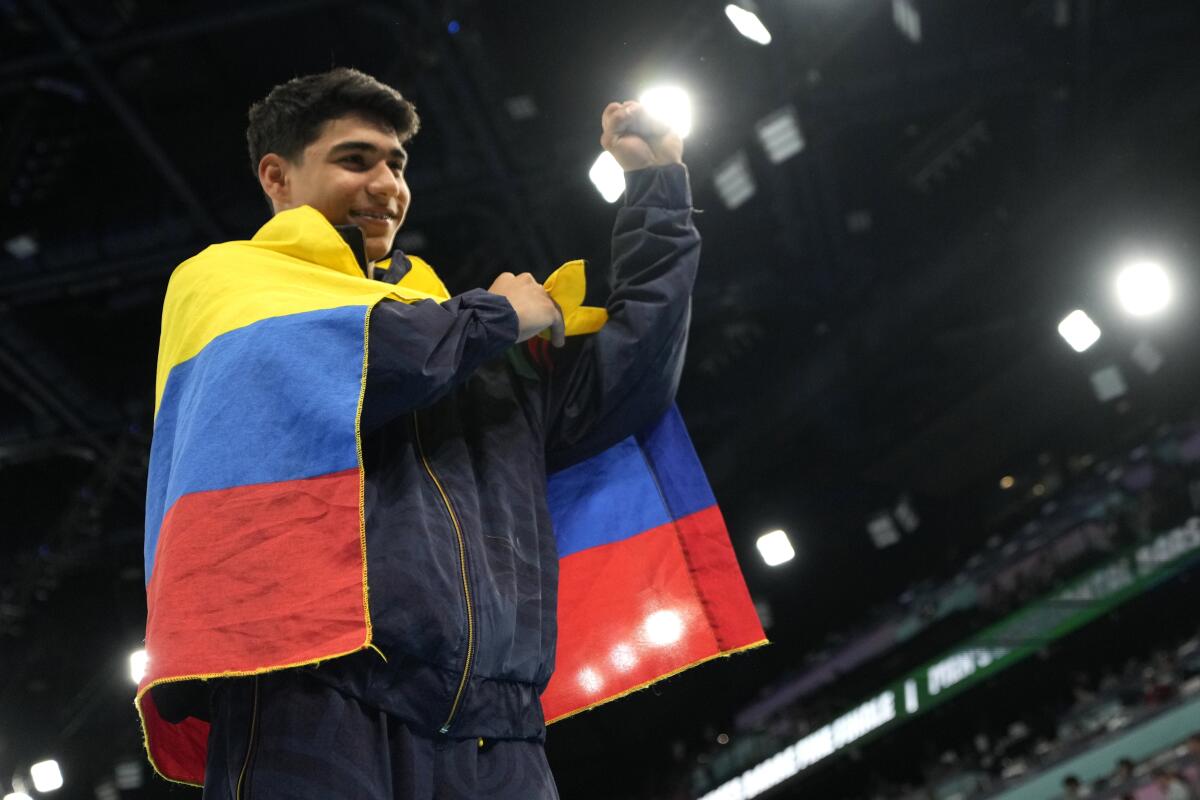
534, 164, 700, 470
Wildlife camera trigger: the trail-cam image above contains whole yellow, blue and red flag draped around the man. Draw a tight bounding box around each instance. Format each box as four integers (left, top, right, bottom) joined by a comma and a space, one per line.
137, 206, 763, 784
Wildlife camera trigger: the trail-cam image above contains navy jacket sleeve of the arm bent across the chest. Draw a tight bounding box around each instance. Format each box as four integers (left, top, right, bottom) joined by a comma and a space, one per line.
360, 289, 518, 432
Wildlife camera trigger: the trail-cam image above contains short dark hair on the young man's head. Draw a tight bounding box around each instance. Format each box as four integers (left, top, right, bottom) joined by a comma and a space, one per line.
246, 67, 421, 175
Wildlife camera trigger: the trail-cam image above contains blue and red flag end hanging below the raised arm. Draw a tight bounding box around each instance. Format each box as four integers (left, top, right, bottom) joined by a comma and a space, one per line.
541, 408, 766, 722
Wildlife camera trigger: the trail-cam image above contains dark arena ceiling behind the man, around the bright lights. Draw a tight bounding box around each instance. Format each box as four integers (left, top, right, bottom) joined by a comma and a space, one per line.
0, 0, 1200, 798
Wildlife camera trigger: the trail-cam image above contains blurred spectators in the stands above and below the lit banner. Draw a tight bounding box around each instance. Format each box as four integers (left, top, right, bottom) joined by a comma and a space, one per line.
681, 421, 1200, 800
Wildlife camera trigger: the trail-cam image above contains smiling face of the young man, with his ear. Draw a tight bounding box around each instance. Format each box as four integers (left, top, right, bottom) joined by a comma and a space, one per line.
258, 115, 412, 261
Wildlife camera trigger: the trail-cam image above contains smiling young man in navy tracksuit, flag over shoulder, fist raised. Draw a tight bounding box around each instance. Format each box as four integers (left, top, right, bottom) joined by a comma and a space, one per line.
139, 70, 700, 800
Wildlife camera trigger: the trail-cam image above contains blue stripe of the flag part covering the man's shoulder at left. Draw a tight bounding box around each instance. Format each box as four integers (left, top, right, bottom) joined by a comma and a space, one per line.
144, 306, 367, 581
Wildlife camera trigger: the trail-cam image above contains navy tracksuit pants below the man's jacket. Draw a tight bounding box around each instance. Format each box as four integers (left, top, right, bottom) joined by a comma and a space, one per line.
204, 669, 558, 800
